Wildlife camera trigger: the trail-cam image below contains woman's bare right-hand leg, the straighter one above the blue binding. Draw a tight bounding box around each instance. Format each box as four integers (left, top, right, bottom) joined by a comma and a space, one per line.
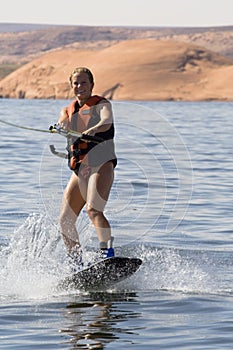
86, 162, 114, 243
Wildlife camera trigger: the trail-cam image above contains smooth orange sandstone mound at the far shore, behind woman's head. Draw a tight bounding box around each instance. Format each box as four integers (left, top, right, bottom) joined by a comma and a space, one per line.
0, 39, 233, 101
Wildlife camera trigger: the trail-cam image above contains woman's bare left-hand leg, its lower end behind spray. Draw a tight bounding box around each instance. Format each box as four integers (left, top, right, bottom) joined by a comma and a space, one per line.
60, 173, 87, 252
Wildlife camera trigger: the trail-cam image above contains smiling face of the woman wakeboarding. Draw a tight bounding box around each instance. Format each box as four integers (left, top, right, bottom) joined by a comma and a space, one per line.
72, 72, 94, 101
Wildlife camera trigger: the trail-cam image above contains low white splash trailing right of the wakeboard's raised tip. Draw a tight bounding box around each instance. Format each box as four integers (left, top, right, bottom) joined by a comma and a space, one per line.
116, 245, 218, 294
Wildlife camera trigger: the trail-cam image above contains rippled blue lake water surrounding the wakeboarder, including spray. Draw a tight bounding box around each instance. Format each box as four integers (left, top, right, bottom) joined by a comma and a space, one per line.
0, 99, 233, 350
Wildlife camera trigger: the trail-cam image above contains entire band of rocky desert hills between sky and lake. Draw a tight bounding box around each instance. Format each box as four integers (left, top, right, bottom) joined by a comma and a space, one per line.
0, 24, 233, 100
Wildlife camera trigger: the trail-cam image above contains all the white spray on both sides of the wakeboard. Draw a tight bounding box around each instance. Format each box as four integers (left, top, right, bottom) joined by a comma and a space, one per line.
0, 214, 226, 299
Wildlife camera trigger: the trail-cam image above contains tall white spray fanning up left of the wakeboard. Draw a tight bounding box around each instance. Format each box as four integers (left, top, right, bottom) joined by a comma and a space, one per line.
0, 214, 65, 298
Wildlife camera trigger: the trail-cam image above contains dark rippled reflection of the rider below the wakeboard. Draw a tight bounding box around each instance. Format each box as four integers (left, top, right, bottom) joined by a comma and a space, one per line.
59, 292, 143, 349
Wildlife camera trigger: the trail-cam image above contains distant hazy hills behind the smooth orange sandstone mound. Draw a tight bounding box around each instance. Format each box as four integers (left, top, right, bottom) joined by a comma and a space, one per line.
0, 23, 233, 63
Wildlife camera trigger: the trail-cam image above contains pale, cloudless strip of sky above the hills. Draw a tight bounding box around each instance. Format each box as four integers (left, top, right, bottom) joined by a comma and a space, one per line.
0, 0, 233, 27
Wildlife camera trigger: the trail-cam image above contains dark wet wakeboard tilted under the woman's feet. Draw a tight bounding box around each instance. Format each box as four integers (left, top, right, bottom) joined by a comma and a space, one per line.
62, 257, 142, 290
